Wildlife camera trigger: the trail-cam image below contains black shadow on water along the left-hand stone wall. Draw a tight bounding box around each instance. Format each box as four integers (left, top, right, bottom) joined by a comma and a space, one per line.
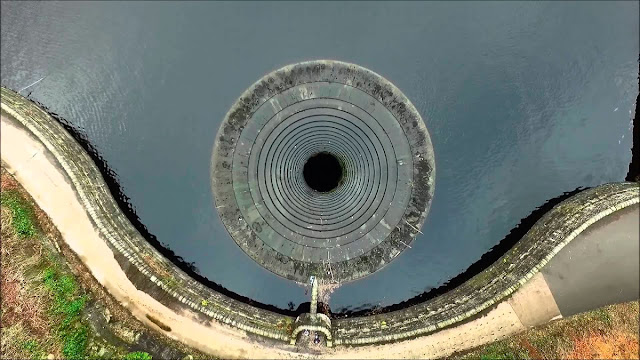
19, 93, 300, 316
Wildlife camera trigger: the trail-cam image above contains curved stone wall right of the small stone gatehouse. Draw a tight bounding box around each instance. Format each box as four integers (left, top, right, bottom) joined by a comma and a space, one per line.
333, 183, 640, 345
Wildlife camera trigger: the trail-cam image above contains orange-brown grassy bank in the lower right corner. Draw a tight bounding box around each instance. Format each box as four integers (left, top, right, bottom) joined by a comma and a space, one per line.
456, 301, 639, 360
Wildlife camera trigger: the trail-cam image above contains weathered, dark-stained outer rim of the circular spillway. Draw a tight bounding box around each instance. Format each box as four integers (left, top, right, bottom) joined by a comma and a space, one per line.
211, 60, 435, 282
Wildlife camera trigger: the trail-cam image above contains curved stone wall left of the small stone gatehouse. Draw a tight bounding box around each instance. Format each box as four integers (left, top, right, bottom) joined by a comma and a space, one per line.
1, 88, 295, 342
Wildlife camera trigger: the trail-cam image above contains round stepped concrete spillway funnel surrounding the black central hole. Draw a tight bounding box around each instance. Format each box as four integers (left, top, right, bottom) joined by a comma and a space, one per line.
211, 61, 435, 282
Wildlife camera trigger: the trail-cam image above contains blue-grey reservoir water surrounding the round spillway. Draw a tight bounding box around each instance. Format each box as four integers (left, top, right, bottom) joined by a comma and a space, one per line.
1, 2, 639, 310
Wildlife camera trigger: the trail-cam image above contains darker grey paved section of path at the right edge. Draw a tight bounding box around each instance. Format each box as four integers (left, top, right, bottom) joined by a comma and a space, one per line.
542, 205, 640, 316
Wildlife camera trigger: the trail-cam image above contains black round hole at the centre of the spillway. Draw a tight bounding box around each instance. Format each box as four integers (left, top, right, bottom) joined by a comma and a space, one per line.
303, 152, 342, 192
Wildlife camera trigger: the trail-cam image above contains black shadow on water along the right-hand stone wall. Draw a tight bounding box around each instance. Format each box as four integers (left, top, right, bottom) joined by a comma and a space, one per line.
332, 188, 588, 318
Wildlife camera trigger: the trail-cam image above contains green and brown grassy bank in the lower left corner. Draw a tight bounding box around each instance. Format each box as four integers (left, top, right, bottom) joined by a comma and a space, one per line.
0, 168, 212, 360
